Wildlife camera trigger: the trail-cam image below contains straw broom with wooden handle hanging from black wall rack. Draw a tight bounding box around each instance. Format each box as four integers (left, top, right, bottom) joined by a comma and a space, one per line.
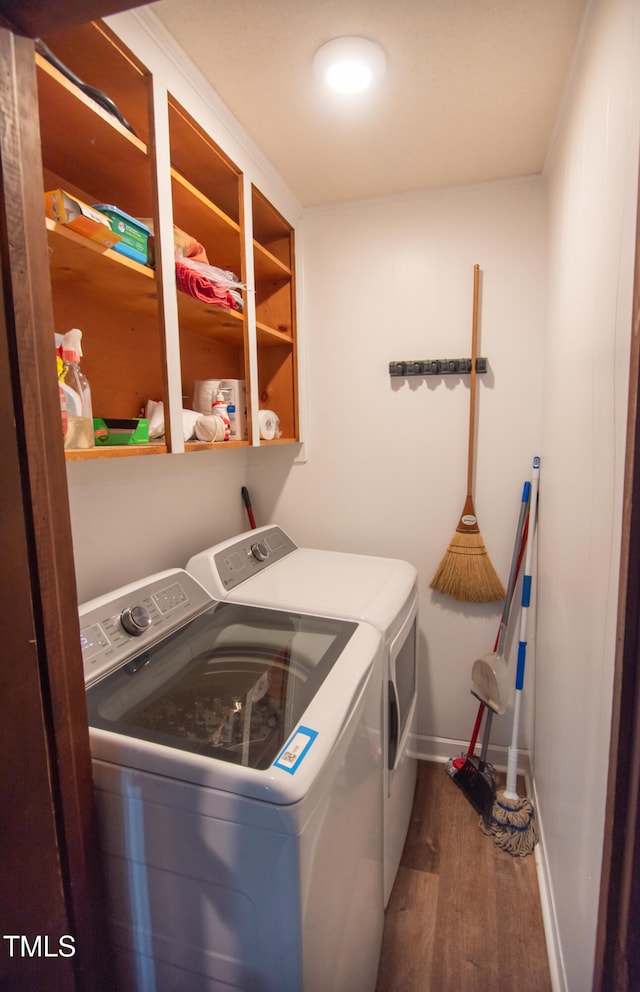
430, 265, 505, 603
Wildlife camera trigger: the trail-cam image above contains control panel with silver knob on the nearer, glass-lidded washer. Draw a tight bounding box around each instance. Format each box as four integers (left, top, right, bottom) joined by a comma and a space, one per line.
79, 569, 215, 685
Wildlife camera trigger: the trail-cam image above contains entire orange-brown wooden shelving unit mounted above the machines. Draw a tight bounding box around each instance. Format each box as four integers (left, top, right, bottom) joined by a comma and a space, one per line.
36, 22, 299, 460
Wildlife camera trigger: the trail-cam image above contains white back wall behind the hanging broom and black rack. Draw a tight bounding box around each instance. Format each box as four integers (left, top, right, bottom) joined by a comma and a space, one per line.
250, 179, 546, 756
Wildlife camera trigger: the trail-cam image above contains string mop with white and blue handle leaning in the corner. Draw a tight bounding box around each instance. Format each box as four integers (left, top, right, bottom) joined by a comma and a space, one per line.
485, 456, 540, 856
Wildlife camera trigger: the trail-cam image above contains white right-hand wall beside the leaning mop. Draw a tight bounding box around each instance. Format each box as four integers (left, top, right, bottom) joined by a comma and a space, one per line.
534, 0, 640, 992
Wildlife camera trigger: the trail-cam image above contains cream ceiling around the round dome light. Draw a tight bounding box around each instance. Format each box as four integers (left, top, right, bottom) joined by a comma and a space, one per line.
150, 0, 587, 206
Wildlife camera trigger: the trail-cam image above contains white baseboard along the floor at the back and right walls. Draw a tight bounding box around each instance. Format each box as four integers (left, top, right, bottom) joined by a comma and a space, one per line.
408, 734, 568, 992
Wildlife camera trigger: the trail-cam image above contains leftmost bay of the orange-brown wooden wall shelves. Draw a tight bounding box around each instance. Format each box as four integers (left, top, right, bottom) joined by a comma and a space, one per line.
36, 23, 167, 450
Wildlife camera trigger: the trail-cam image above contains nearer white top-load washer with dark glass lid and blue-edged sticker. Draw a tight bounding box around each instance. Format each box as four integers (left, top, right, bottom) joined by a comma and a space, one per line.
79, 569, 384, 992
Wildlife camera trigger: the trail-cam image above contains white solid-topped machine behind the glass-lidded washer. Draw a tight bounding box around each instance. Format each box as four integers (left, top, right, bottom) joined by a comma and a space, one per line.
186, 526, 418, 906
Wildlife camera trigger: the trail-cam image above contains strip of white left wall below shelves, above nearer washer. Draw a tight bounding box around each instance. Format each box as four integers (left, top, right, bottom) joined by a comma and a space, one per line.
67, 448, 248, 603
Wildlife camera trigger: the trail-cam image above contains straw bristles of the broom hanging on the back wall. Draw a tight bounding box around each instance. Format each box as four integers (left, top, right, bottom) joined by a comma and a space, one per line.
429, 531, 505, 603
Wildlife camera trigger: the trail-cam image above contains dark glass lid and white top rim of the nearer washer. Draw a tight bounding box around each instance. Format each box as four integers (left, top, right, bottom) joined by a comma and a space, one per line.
87, 603, 379, 803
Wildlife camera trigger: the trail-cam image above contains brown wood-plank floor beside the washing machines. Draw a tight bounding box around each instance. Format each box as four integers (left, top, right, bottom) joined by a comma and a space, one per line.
377, 761, 551, 992
